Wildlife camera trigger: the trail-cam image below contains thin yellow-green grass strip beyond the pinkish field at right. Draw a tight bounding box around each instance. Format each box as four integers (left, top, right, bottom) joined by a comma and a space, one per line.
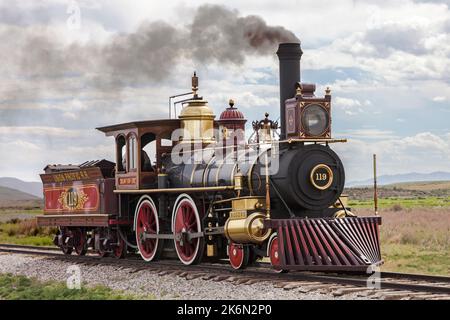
349, 196, 450, 209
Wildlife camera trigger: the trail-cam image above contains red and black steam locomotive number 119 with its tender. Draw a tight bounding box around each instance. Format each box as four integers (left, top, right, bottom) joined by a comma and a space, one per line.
37, 43, 382, 271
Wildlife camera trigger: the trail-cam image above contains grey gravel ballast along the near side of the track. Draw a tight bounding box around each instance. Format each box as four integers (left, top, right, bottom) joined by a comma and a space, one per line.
0, 253, 370, 300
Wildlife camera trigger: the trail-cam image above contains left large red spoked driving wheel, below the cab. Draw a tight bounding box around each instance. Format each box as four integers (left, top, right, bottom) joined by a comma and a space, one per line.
134, 196, 162, 261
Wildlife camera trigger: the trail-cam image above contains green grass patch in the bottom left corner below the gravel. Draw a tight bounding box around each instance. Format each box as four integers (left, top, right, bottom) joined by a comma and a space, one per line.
0, 274, 154, 300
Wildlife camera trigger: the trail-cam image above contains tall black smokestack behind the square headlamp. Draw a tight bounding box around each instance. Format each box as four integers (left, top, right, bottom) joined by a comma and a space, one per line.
277, 43, 303, 139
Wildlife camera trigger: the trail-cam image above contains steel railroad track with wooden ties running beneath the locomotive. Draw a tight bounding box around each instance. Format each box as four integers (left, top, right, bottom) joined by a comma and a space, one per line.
0, 244, 450, 300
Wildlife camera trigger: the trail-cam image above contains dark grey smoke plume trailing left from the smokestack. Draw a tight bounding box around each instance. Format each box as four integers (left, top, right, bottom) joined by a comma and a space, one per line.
0, 5, 299, 101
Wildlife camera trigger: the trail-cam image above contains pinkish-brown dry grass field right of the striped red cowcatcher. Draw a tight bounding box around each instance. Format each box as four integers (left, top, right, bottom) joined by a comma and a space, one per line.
354, 207, 450, 275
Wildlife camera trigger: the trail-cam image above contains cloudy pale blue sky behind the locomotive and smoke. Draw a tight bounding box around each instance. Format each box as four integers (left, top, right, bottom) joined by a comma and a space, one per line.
0, 0, 450, 181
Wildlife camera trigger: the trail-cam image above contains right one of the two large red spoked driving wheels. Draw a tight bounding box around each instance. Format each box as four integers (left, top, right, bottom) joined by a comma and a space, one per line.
172, 196, 204, 265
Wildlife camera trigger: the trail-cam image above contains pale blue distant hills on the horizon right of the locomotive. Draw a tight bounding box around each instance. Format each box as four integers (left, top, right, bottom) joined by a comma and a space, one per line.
346, 171, 450, 187
